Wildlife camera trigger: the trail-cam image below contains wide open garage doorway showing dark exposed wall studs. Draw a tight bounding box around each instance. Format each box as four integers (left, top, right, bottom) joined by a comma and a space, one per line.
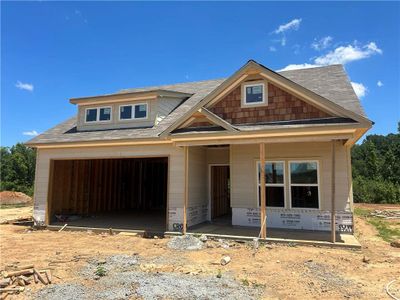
48, 157, 168, 232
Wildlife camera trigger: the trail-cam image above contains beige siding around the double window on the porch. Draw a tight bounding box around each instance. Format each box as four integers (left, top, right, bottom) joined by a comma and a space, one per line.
231, 142, 351, 210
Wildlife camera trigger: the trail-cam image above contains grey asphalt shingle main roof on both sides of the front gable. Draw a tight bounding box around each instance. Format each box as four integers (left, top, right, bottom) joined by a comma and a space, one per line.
27, 65, 365, 145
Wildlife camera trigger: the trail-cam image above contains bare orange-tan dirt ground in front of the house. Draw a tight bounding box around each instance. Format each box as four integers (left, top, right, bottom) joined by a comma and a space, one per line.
0, 204, 400, 299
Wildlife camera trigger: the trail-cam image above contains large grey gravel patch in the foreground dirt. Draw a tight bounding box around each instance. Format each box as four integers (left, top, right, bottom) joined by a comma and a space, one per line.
33, 255, 263, 300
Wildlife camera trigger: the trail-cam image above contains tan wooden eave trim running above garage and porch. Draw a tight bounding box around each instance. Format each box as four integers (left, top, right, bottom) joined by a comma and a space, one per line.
27, 123, 369, 149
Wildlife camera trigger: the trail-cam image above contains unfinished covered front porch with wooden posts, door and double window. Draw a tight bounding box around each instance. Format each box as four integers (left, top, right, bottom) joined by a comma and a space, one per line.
180, 139, 359, 246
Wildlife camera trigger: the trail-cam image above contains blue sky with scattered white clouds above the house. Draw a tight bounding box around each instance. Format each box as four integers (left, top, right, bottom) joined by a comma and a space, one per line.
1, 1, 400, 146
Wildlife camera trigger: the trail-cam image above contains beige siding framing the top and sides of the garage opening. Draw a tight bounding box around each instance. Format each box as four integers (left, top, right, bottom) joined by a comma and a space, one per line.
34, 145, 184, 221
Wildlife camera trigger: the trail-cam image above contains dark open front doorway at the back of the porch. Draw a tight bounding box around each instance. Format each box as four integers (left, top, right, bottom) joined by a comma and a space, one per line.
210, 166, 232, 224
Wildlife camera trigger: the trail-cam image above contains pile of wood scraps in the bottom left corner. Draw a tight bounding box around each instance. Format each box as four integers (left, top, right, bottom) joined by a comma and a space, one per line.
0, 264, 52, 299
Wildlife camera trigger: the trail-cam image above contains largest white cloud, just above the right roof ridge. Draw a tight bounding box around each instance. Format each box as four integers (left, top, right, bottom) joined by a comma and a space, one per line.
314, 42, 382, 66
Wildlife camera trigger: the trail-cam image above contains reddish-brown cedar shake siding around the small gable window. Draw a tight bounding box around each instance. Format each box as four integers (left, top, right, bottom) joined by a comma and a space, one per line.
209, 83, 332, 124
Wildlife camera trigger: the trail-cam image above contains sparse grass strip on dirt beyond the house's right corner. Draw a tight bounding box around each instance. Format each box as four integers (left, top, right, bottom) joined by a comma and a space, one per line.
354, 207, 400, 243
